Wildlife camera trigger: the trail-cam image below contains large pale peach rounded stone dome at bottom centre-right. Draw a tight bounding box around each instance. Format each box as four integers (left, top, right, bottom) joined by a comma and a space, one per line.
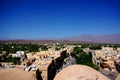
54, 65, 110, 80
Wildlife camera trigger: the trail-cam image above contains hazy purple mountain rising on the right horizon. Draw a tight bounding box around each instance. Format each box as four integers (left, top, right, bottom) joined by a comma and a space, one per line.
65, 34, 120, 44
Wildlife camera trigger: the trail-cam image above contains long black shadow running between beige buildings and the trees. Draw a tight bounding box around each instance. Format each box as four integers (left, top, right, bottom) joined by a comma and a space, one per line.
48, 50, 69, 80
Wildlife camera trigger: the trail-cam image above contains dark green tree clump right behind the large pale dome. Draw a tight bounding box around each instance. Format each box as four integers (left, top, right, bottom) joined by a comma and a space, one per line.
71, 47, 99, 70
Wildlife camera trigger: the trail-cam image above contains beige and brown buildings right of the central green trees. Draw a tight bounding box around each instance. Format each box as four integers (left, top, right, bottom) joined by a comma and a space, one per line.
91, 47, 120, 78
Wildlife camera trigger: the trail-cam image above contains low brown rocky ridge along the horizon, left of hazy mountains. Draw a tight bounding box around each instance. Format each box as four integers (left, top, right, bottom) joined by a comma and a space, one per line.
0, 40, 90, 44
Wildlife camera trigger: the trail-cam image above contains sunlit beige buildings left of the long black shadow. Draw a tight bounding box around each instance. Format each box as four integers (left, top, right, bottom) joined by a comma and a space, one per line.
16, 46, 75, 80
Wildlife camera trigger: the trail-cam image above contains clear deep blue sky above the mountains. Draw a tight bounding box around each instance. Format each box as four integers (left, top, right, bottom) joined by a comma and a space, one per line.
0, 0, 120, 39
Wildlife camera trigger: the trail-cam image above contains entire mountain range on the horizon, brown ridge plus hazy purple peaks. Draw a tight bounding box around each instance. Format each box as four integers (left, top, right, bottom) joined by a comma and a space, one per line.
0, 34, 120, 44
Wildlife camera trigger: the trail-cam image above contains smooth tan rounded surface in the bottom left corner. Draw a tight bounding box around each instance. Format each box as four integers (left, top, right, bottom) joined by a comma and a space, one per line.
0, 68, 36, 80
